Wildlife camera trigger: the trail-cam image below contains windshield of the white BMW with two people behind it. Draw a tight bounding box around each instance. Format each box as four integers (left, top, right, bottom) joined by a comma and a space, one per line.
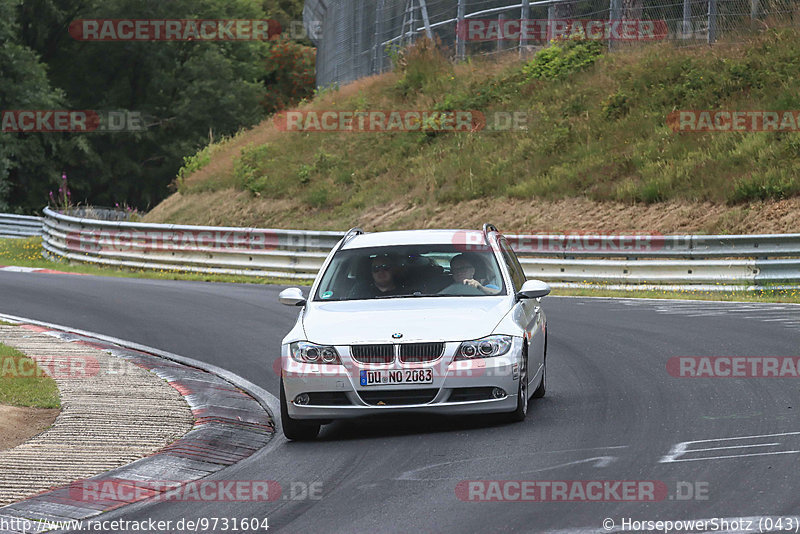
314, 245, 506, 301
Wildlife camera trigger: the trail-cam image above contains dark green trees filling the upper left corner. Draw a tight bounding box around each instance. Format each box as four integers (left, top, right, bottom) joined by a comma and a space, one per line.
0, 0, 306, 212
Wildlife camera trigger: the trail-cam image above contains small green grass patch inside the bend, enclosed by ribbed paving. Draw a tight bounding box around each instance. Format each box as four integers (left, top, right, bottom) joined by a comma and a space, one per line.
0, 343, 61, 408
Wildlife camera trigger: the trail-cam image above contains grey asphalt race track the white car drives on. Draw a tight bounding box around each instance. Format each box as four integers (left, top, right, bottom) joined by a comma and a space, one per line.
0, 272, 800, 533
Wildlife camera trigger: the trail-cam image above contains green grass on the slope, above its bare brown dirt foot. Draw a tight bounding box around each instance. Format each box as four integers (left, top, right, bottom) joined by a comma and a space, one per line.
181, 29, 800, 211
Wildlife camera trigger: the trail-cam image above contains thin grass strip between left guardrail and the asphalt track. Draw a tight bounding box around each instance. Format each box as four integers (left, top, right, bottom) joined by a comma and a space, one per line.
0, 237, 311, 285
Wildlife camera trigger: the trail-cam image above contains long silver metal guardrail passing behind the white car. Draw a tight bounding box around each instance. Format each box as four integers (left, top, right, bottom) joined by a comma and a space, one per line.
43, 208, 800, 290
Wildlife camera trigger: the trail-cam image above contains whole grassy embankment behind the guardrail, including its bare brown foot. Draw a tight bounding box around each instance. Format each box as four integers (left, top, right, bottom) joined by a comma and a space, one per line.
152, 30, 800, 234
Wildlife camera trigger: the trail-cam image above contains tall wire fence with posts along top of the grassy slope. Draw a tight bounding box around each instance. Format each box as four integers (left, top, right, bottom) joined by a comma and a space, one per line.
303, 0, 800, 86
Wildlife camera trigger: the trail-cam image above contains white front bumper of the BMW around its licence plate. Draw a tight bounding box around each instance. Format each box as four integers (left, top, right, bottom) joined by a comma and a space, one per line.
281, 337, 522, 419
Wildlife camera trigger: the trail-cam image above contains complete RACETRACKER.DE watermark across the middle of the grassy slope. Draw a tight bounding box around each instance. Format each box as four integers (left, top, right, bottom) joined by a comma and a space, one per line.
273, 110, 529, 133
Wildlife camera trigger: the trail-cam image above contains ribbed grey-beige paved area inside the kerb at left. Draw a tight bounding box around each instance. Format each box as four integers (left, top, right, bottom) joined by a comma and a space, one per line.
0, 325, 194, 506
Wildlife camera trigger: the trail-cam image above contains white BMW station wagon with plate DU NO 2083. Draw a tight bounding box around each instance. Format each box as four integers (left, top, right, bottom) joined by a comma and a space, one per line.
279, 224, 550, 440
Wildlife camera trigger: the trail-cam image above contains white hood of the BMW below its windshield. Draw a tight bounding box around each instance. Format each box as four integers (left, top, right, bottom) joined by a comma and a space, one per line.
303, 296, 508, 345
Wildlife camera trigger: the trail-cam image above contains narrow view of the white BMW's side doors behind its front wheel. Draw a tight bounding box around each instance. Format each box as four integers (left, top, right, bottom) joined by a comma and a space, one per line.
499, 237, 544, 391
